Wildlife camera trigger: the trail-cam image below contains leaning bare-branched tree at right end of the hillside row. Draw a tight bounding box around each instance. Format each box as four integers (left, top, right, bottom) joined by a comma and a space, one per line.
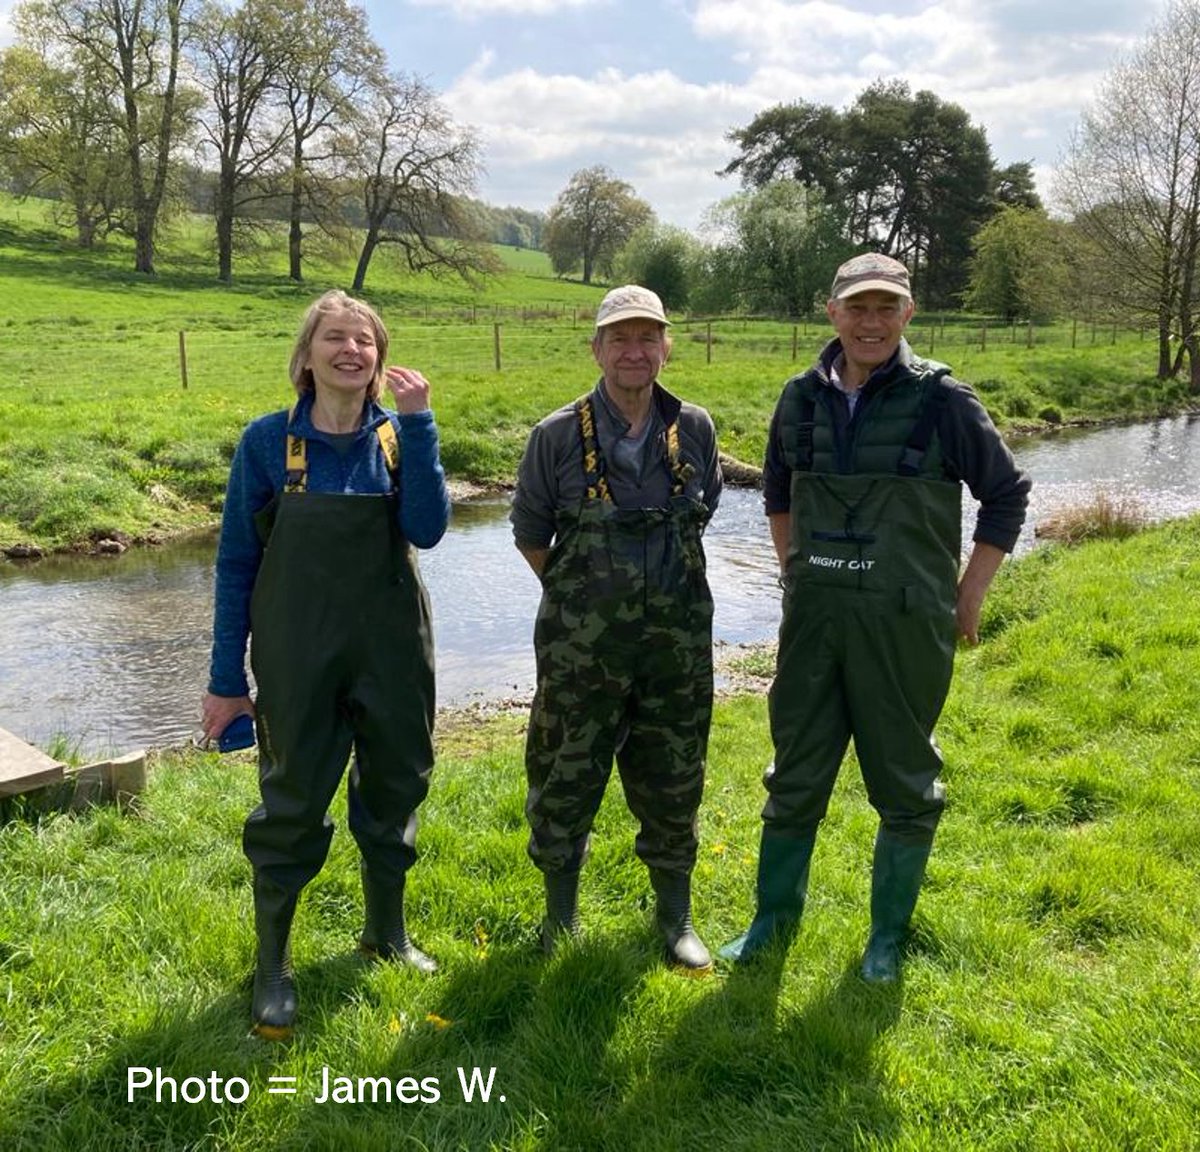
352, 74, 497, 292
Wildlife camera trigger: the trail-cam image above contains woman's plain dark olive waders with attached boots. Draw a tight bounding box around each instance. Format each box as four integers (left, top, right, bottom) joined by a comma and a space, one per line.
242, 492, 434, 1038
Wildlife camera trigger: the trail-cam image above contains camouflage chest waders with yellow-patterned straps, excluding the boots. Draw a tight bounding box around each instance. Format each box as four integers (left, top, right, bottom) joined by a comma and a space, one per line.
526, 402, 713, 874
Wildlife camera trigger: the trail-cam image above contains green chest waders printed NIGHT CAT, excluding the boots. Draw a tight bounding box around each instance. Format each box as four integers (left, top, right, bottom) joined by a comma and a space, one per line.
763, 472, 961, 835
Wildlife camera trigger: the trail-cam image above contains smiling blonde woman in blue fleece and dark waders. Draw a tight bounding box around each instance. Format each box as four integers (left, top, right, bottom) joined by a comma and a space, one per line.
203, 292, 450, 1039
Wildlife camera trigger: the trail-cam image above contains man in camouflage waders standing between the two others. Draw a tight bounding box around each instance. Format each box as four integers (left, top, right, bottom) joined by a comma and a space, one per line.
511, 284, 721, 973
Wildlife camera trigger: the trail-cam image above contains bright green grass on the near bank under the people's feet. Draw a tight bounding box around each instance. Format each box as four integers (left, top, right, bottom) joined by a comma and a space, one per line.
0, 520, 1200, 1152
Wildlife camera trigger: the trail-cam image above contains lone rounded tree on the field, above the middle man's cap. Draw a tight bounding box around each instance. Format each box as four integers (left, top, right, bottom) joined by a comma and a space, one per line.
542, 164, 653, 284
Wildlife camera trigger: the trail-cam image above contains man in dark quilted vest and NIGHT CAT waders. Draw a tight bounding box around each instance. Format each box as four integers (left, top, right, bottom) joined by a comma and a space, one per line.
721, 252, 1030, 983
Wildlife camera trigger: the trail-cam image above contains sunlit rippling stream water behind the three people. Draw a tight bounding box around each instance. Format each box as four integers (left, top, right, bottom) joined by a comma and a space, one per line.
0, 418, 1200, 755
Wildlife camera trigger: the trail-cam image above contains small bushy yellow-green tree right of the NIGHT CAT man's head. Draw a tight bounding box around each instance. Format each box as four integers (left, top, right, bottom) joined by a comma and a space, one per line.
965, 208, 1068, 322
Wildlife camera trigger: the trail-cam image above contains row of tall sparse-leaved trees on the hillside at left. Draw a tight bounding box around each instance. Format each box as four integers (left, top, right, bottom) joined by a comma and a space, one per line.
0, 0, 541, 289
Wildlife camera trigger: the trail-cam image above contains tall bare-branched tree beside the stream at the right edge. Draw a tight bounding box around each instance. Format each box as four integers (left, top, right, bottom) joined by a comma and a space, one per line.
1055, 0, 1200, 392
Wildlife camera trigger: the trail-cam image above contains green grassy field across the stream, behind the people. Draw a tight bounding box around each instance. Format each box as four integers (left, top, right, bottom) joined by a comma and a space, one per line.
0, 197, 1192, 550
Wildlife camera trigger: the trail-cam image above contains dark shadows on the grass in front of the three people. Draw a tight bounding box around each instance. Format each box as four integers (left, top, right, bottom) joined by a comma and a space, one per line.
0, 907, 902, 1152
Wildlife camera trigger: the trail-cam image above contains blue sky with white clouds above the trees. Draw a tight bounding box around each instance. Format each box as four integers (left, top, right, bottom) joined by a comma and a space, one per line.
0, 0, 1162, 229
